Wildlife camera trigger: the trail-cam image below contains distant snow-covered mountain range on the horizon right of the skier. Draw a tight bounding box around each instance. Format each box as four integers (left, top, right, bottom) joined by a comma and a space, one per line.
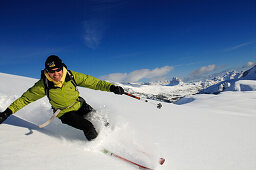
120, 66, 256, 103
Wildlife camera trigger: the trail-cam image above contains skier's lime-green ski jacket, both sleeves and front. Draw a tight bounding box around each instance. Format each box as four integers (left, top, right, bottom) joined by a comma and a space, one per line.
8, 71, 113, 117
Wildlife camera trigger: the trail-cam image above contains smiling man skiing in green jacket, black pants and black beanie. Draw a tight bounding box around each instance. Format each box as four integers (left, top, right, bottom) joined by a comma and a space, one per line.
0, 55, 124, 141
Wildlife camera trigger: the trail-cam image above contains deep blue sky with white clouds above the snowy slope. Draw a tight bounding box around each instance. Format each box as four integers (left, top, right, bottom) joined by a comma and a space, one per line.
0, 0, 256, 81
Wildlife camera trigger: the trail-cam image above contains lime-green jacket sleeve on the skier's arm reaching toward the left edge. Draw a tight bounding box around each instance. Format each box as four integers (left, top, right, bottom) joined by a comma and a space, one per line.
8, 79, 45, 113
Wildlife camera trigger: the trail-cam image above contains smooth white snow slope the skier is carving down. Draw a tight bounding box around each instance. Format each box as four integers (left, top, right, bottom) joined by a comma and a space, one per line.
0, 73, 256, 170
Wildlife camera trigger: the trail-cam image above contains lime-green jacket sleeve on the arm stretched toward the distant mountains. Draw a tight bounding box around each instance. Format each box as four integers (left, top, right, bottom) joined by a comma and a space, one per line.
71, 71, 113, 92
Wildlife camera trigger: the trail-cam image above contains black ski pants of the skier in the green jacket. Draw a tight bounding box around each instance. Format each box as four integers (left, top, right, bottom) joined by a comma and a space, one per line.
60, 101, 98, 141
